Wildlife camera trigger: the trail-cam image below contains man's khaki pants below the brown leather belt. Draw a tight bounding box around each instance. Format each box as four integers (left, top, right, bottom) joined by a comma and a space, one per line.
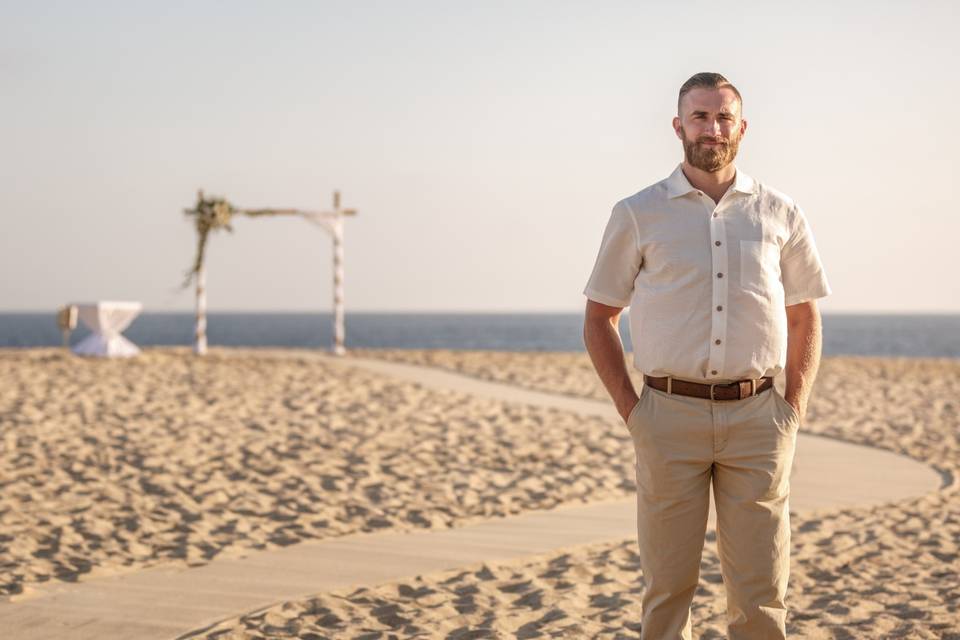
627, 385, 800, 640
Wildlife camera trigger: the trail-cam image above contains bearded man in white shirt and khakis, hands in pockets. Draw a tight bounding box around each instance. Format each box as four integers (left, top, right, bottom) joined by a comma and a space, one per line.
584, 73, 831, 640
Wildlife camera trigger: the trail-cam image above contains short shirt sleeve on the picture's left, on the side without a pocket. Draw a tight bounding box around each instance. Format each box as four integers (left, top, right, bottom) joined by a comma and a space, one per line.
583, 200, 643, 307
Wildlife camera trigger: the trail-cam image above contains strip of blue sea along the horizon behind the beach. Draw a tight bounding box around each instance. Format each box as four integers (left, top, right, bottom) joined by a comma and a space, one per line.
0, 312, 960, 358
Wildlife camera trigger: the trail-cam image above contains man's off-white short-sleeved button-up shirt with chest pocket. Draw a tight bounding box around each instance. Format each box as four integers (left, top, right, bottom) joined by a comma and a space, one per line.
583, 164, 831, 382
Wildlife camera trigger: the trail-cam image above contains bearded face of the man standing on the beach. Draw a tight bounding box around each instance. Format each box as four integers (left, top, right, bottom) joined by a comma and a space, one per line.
673, 87, 747, 173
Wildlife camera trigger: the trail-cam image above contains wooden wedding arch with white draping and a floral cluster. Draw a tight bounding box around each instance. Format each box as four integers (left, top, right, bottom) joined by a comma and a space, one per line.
183, 189, 357, 356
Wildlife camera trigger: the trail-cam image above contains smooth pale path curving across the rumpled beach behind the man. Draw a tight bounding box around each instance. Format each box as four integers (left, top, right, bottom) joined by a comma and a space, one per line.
0, 350, 941, 640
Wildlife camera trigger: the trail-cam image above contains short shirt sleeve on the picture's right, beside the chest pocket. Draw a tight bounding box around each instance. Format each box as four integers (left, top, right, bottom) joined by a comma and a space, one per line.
780, 205, 832, 307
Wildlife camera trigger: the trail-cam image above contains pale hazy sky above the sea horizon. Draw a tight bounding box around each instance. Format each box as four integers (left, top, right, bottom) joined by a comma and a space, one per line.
0, 0, 960, 313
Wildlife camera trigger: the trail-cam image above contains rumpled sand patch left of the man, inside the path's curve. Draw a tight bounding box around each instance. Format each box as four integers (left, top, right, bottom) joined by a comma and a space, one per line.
0, 349, 632, 595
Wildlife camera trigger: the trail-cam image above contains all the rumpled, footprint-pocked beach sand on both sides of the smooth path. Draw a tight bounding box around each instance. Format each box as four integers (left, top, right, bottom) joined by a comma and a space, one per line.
0, 348, 960, 639
